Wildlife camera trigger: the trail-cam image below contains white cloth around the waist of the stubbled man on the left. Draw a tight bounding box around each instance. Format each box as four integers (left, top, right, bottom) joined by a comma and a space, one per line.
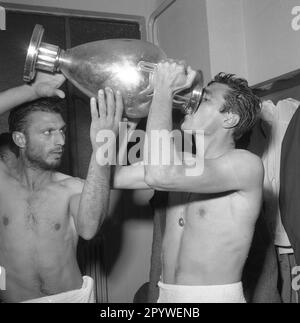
22, 276, 95, 303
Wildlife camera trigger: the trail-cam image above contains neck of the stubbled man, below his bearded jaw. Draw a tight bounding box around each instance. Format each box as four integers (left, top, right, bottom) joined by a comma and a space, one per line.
17, 157, 54, 191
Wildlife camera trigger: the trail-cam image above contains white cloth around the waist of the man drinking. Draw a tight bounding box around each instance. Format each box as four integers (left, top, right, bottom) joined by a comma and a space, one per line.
157, 282, 246, 303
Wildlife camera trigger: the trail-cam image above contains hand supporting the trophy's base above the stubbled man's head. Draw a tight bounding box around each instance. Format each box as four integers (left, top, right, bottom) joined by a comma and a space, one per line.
31, 72, 66, 99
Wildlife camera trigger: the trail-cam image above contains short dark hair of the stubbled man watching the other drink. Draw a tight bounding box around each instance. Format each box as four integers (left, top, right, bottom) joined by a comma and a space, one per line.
8, 98, 62, 133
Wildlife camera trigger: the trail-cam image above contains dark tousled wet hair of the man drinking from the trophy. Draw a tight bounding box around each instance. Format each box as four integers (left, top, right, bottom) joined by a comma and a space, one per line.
208, 73, 261, 140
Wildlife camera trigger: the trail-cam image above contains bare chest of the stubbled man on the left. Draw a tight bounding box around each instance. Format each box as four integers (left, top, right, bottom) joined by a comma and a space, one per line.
0, 185, 69, 235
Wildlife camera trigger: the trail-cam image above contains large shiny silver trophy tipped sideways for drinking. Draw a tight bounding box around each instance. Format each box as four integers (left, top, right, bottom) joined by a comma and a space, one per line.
24, 25, 203, 118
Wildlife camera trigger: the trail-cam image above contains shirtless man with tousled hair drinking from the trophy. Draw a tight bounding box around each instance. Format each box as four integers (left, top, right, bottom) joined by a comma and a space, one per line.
114, 60, 264, 303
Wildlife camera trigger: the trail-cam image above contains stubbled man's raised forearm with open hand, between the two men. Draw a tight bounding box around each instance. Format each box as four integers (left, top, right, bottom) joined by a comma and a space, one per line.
70, 89, 123, 240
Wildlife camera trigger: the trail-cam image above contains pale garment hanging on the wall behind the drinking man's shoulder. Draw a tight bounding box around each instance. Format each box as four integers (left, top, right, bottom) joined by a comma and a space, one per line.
248, 99, 299, 254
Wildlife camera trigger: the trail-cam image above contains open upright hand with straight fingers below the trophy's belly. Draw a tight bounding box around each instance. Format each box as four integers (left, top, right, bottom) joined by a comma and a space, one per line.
90, 88, 124, 153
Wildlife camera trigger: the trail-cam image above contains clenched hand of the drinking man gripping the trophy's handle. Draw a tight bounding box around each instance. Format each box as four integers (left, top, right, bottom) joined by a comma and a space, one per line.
153, 59, 196, 94
